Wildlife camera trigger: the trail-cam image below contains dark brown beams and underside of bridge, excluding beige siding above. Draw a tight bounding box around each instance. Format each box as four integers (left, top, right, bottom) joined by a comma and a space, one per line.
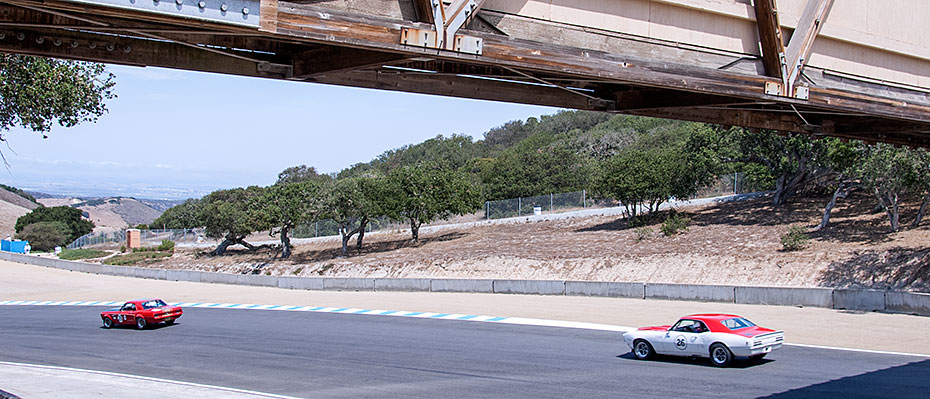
0, 0, 930, 147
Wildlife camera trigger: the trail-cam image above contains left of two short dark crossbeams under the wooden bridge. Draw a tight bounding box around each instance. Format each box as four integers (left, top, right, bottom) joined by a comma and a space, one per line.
292, 47, 407, 79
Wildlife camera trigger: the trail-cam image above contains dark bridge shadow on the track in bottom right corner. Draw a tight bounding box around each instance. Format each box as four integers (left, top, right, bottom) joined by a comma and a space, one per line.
752, 360, 930, 399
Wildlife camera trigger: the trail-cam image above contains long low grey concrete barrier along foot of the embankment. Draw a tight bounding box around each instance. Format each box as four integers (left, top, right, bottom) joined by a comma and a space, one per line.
0, 252, 930, 316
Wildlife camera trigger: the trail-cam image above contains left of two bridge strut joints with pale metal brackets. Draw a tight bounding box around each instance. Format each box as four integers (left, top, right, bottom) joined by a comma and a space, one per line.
400, 0, 484, 55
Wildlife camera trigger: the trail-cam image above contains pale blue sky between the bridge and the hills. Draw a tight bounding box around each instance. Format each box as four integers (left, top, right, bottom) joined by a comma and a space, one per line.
0, 66, 557, 199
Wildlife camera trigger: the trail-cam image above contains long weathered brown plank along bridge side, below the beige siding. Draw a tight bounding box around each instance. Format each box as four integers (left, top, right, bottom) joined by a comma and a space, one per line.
270, 3, 930, 122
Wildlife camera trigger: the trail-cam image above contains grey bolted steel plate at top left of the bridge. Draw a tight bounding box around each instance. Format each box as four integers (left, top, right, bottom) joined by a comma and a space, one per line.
69, 0, 261, 28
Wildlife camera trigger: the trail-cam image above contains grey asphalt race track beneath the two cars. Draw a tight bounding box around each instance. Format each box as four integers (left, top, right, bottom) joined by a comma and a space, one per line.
0, 306, 930, 399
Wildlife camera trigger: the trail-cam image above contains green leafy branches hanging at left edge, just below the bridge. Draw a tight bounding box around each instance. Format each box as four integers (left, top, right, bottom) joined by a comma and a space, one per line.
0, 53, 116, 151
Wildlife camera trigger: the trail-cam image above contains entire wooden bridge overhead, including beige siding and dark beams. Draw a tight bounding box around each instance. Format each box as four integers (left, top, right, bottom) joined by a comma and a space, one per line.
0, 0, 930, 147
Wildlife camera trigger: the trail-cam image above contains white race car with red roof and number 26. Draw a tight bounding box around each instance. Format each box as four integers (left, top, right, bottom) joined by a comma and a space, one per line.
623, 314, 785, 367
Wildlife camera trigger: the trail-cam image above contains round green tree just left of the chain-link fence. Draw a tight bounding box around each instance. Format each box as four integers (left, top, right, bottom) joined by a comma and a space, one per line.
385, 165, 482, 241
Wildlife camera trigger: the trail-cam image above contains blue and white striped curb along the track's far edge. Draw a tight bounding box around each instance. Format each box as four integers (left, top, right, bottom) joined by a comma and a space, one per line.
0, 301, 634, 332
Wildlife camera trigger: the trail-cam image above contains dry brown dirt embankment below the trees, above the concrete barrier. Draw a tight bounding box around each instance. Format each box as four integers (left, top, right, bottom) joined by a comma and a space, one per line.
114, 194, 930, 291
